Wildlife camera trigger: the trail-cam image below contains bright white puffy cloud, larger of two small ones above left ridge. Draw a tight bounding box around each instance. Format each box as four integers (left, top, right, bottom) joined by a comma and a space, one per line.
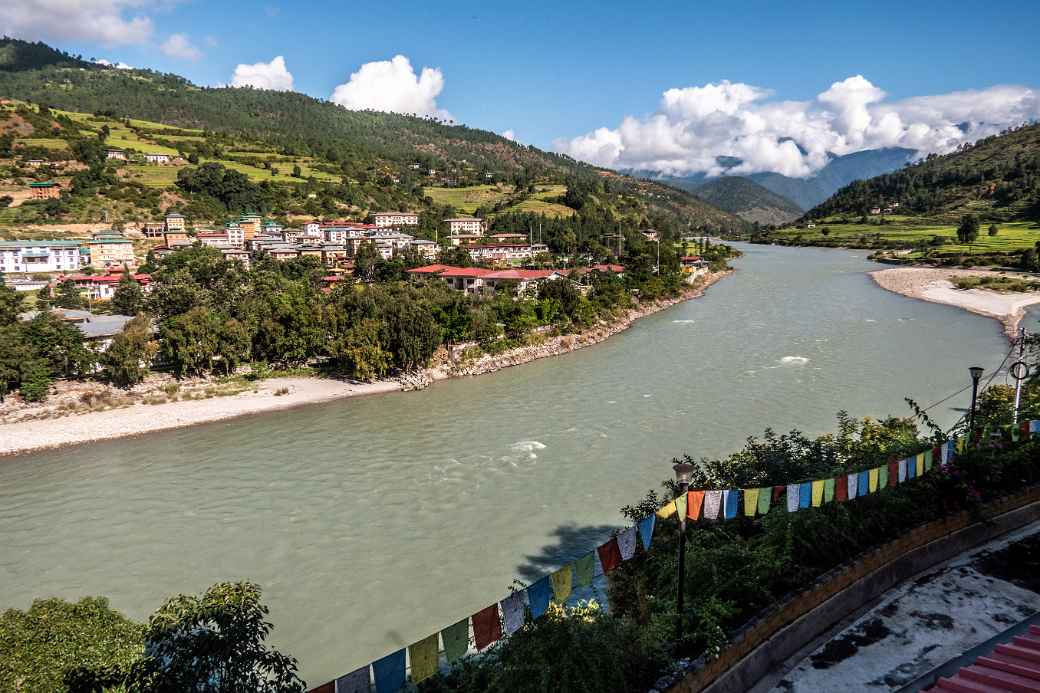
331, 55, 451, 120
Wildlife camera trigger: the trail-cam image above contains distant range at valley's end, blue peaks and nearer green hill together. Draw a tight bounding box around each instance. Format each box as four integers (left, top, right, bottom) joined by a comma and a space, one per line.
629, 147, 916, 224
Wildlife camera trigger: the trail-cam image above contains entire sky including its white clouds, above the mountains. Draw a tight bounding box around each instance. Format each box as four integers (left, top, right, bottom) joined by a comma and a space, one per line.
0, 0, 1040, 176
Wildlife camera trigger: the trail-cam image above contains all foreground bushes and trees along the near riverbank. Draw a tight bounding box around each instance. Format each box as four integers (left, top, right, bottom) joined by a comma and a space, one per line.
8, 382, 1040, 693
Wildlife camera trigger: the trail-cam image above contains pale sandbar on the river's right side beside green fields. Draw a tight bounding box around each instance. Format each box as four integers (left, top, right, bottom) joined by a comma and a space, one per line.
868, 267, 1040, 338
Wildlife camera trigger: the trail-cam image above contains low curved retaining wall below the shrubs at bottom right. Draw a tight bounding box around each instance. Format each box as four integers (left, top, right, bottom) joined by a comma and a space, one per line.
669, 487, 1040, 693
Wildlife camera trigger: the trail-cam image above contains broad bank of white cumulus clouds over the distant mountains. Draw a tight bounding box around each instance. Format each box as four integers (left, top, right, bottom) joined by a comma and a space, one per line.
553, 75, 1040, 177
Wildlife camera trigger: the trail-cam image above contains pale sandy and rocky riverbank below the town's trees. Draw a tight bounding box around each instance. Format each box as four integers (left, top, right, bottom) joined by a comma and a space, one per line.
0, 271, 732, 456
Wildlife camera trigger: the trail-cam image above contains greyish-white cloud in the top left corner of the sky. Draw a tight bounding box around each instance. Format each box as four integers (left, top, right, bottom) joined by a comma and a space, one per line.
0, 0, 153, 44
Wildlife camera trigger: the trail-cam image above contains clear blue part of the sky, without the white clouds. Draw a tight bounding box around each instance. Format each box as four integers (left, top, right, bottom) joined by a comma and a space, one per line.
0, 0, 1040, 172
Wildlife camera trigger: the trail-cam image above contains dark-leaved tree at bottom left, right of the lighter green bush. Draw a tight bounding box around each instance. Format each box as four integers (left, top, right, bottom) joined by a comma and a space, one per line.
128, 583, 304, 693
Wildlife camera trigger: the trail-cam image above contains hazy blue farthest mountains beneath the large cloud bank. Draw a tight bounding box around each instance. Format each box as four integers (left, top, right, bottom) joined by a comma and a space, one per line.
639, 147, 916, 210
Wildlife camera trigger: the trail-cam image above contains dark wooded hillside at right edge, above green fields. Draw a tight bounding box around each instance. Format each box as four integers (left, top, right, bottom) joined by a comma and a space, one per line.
806, 124, 1040, 222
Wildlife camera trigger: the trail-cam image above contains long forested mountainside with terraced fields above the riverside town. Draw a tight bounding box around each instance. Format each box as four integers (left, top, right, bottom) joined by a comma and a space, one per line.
0, 39, 745, 229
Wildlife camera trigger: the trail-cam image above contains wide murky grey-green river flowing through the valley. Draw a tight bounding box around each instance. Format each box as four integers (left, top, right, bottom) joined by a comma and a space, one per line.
0, 241, 1008, 685
